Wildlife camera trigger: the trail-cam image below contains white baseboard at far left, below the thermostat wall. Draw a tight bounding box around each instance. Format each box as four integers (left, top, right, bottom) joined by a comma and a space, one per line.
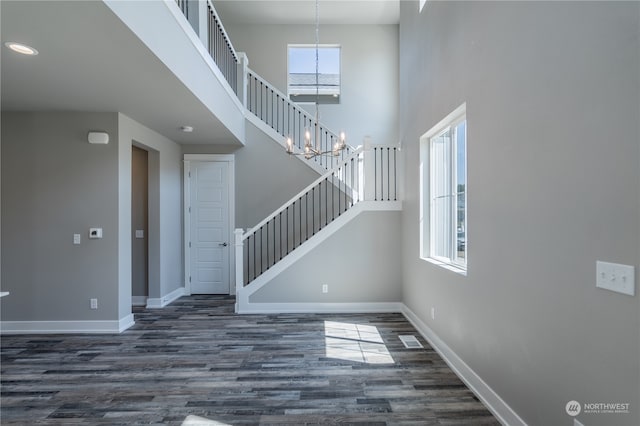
0, 314, 135, 334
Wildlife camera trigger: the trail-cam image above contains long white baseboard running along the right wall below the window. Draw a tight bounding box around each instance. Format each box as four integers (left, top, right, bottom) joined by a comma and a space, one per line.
401, 304, 527, 426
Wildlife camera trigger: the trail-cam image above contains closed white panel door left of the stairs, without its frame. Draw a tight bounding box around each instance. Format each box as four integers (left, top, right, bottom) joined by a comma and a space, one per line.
189, 161, 231, 294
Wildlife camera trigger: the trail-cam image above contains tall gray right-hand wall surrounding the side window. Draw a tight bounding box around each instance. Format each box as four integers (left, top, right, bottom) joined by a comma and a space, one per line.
400, 1, 640, 425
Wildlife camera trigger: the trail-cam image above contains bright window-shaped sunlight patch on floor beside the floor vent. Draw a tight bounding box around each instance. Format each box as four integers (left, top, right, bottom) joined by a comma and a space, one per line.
324, 321, 393, 364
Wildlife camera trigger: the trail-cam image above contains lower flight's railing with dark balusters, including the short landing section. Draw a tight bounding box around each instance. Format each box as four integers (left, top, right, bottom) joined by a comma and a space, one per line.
235, 139, 400, 289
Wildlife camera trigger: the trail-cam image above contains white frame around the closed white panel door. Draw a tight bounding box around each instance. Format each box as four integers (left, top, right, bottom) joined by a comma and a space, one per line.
183, 154, 236, 295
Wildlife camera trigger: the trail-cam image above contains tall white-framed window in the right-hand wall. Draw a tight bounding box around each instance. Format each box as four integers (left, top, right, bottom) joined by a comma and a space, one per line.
421, 104, 467, 270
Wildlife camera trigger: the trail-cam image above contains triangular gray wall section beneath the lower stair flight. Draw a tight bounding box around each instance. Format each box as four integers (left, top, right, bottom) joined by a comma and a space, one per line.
249, 212, 402, 303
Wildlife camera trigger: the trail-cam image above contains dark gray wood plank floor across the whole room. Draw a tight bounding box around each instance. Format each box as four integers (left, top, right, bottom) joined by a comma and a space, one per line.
0, 296, 498, 425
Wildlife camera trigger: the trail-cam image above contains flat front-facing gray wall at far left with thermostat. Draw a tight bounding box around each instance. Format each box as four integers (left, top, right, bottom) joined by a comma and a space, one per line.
2, 113, 122, 321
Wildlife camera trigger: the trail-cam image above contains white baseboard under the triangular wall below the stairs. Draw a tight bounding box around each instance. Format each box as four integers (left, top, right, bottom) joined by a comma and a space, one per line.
236, 302, 402, 314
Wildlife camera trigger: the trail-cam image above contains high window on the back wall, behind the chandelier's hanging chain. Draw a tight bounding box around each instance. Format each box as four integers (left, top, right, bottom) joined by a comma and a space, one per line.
287, 44, 340, 103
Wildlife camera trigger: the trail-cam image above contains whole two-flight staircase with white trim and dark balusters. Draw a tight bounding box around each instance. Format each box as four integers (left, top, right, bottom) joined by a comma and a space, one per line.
176, 0, 402, 312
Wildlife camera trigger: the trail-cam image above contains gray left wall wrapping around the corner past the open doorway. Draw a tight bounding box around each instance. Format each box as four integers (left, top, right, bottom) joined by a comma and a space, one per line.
2, 112, 184, 321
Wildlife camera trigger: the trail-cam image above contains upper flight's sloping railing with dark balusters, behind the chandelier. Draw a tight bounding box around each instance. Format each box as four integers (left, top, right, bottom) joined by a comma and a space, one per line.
246, 68, 353, 170
